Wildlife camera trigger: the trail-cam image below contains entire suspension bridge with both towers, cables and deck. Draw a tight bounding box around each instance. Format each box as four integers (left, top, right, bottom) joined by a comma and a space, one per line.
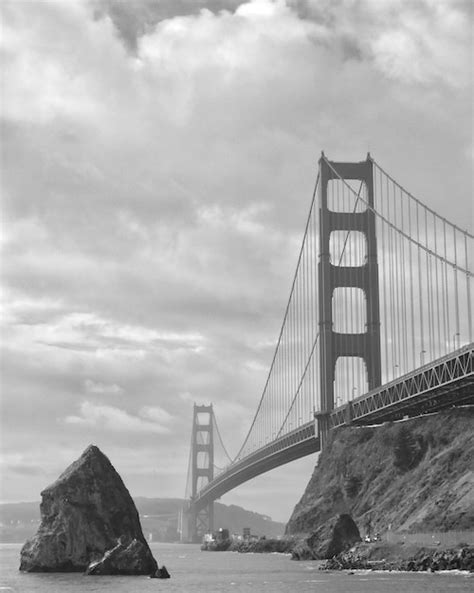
182, 153, 474, 541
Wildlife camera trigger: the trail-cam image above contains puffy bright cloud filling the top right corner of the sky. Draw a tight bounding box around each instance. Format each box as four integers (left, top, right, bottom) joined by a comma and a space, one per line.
290, 0, 471, 88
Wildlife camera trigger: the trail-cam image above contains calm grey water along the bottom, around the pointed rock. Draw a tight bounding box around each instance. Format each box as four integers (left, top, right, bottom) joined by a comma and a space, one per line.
0, 544, 474, 593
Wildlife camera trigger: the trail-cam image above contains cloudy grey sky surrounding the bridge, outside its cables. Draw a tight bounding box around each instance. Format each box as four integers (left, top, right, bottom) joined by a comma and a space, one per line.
0, 0, 474, 521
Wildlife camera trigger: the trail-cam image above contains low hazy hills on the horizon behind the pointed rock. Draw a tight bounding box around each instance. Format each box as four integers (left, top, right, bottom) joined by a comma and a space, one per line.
0, 497, 285, 543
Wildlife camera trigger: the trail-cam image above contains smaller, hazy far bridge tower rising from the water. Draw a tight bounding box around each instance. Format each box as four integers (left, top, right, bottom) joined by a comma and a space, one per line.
188, 404, 214, 542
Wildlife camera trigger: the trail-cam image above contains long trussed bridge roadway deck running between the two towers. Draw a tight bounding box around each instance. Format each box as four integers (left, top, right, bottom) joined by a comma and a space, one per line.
191, 343, 474, 510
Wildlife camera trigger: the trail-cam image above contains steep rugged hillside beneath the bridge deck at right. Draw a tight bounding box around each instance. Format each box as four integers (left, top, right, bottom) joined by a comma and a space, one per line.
286, 407, 474, 535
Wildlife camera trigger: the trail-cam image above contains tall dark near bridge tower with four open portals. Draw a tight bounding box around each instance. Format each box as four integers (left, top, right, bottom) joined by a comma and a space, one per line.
316, 153, 381, 448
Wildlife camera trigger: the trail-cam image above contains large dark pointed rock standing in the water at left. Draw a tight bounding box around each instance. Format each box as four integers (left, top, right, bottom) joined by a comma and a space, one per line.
20, 445, 158, 574
